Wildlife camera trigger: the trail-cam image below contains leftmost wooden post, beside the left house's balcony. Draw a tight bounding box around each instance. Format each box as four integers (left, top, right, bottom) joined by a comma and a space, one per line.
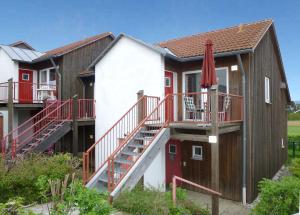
6, 78, 14, 147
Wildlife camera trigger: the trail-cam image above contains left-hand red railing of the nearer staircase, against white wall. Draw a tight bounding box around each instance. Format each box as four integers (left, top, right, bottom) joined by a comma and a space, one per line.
83, 96, 159, 183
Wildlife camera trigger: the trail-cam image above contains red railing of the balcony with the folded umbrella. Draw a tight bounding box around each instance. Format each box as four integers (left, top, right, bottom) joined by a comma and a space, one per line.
166, 92, 243, 124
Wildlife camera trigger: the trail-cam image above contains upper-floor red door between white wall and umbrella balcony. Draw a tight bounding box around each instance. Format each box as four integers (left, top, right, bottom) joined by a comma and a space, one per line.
165, 71, 174, 121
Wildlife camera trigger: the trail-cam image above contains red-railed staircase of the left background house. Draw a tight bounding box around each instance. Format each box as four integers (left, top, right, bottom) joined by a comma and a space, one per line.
1, 99, 72, 159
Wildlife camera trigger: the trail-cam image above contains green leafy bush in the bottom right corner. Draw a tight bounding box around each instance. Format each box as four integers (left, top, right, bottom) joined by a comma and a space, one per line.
251, 176, 300, 215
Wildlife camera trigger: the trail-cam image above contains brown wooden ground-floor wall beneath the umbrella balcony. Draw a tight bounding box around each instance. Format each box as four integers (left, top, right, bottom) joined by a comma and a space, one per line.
181, 132, 242, 201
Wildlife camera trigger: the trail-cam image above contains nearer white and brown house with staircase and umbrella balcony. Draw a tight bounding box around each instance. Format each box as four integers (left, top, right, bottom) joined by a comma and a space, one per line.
82, 20, 291, 203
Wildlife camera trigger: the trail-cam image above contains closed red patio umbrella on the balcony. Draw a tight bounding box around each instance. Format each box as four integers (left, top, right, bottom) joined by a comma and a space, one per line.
200, 39, 217, 88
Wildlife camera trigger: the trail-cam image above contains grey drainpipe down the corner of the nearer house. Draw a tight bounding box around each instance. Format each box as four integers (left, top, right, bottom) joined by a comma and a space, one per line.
236, 54, 247, 205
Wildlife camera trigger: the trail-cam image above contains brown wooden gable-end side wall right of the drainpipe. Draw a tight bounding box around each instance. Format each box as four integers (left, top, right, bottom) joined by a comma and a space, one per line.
247, 28, 287, 201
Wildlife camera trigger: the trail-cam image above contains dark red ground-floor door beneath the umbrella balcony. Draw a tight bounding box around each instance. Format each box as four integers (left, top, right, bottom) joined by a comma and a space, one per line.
166, 139, 182, 184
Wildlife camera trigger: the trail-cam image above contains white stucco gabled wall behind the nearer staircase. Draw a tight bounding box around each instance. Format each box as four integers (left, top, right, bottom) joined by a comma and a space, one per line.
94, 37, 165, 189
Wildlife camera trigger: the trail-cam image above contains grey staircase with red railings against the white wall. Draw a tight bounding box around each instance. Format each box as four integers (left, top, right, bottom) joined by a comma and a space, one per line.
83, 96, 170, 197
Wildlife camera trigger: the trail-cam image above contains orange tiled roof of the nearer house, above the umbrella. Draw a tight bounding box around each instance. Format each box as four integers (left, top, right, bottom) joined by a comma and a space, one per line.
158, 20, 273, 58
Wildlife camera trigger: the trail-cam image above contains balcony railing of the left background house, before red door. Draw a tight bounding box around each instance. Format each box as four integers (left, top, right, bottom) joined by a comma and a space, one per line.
0, 82, 57, 103
